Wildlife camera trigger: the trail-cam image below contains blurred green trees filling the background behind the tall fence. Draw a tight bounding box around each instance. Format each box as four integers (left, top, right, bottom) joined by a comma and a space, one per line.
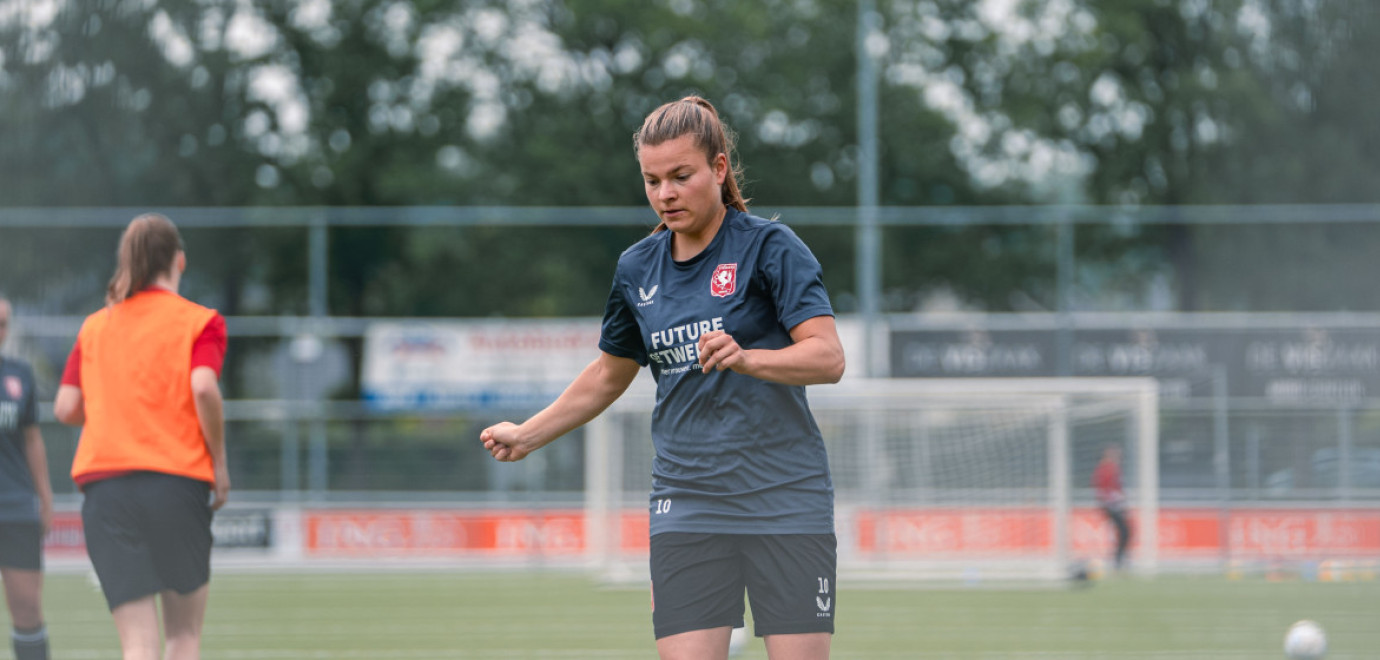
0, 0, 1380, 316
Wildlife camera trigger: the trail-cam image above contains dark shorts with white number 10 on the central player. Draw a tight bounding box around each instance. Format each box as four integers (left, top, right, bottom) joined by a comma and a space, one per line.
651, 533, 838, 639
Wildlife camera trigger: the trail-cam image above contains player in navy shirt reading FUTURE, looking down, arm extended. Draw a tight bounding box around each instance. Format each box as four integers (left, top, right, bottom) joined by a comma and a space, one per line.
480, 97, 843, 660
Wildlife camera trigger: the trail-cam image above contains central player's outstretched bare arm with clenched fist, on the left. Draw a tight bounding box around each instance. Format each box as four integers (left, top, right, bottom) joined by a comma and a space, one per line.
479, 353, 642, 463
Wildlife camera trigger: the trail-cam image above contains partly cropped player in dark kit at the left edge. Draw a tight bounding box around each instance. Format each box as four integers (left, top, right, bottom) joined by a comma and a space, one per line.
0, 295, 52, 660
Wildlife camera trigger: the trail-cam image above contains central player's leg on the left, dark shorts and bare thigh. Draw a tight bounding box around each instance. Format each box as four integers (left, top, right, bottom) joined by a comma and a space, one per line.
651, 533, 744, 660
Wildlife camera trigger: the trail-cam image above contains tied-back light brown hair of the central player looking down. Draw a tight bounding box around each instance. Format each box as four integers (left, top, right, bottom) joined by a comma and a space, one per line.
632, 95, 748, 233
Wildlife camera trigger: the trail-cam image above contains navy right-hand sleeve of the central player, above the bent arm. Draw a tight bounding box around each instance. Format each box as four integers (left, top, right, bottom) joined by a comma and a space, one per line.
758, 224, 834, 330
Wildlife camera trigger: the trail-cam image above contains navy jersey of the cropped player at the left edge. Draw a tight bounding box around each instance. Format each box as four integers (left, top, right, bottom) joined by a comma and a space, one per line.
0, 358, 39, 522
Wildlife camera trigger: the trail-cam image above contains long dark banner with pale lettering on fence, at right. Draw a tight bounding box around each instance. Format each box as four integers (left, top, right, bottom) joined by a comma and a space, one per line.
890, 327, 1380, 403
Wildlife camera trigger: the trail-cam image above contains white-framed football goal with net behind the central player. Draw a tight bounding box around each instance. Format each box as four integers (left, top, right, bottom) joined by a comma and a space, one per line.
585, 378, 1159, 583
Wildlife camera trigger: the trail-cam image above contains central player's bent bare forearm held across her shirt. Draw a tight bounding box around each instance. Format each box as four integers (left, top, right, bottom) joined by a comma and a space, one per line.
698, 316, 845, 385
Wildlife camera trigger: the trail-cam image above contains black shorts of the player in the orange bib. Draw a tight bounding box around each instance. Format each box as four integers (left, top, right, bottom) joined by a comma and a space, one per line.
81, 472, 211, 610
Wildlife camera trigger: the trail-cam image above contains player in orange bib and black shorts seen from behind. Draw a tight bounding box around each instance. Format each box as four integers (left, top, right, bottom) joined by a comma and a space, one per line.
54, 214, 230, 660
